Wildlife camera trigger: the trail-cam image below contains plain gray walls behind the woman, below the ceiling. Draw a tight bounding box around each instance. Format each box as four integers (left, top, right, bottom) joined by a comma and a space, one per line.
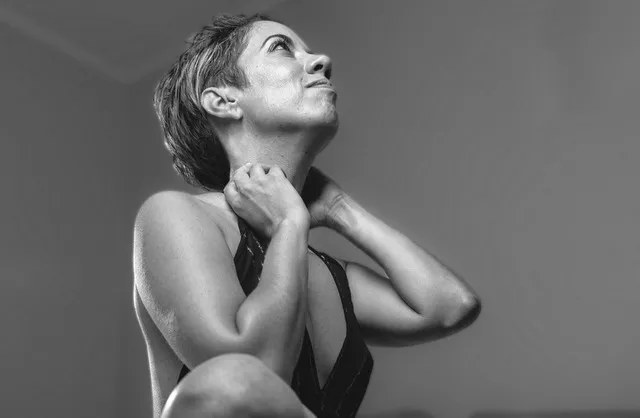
0, 0, 640, 418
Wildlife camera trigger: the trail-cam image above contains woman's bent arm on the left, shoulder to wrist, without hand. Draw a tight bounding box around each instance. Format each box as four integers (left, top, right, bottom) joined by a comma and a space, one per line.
134, 192, 309, 382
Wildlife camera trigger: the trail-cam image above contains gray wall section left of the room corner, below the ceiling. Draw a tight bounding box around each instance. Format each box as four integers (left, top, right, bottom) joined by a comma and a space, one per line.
0, 25, 131, 418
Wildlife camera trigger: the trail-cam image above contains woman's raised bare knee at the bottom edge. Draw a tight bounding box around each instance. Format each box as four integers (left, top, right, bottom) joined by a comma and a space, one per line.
162, 353, 315, 418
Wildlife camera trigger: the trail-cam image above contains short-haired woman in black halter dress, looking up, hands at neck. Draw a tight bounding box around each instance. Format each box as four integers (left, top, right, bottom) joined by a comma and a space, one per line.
134, 15, 480, 418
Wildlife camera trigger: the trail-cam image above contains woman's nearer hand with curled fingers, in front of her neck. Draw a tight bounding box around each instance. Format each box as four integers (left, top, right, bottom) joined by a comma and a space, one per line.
224, 163, 310, 239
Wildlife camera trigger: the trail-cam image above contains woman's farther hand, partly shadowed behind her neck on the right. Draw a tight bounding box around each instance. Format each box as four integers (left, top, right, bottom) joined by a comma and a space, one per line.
301, 167, 344, 228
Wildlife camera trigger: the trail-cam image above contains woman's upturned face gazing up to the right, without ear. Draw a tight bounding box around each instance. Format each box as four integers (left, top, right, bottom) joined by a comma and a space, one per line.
238, 21, 338, 133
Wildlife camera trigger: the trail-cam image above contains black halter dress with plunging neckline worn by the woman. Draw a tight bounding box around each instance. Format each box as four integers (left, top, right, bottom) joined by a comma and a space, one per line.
178, 218, 373, 418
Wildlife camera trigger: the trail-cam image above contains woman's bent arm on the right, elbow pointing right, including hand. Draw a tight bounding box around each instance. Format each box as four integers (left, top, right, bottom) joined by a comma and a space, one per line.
303, 168, 480, 346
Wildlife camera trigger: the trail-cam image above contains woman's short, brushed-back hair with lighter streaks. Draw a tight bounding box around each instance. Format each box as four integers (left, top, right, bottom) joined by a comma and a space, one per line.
153, 14, 274, 191
